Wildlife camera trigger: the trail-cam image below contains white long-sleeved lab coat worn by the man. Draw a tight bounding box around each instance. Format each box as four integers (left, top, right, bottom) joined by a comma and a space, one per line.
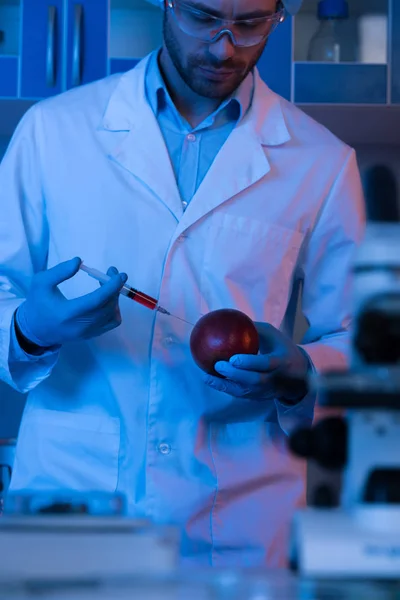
0, 51, 363, 567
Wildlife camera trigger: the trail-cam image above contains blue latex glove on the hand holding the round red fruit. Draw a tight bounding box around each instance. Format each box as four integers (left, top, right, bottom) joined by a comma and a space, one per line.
205, 323, 311, 404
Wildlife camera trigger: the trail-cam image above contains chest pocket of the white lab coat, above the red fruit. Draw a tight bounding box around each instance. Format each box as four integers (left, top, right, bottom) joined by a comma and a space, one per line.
201, 212, 304, 327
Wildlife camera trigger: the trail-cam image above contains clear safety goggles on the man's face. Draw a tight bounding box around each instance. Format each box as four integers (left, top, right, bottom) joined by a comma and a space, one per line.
167, 0, 285, 48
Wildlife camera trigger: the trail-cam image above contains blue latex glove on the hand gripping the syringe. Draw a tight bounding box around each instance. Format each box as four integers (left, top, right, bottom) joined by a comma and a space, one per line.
15, 258, 127, 348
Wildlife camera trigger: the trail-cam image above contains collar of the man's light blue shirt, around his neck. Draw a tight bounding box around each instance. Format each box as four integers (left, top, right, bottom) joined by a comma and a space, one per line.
146, 51, 254, 129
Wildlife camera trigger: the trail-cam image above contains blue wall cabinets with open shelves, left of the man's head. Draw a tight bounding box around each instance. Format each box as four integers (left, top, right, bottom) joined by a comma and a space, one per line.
0, 0, 162, 100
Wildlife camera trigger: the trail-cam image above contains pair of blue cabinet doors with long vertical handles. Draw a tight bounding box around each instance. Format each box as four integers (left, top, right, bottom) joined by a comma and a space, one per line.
19, 0, 108, 98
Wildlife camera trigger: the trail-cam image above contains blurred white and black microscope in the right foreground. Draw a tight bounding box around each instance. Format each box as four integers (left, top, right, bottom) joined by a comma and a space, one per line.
289, 166, 400, 580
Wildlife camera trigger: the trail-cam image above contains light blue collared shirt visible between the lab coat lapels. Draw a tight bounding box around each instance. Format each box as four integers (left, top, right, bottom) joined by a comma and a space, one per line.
146, 53, 254, 209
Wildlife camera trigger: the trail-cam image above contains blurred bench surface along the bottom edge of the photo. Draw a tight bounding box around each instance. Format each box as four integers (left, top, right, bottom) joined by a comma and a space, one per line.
0, 571, 400, 600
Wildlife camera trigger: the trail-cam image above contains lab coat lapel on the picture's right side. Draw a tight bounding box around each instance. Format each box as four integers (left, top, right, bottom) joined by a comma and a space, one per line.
176, 71, 290, 237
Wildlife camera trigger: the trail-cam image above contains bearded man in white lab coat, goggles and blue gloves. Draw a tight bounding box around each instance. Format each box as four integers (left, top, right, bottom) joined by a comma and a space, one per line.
0, 0, 363, 567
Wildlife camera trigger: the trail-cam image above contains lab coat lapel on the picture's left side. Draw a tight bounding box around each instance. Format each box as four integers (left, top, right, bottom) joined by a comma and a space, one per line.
103, 58, 183, 221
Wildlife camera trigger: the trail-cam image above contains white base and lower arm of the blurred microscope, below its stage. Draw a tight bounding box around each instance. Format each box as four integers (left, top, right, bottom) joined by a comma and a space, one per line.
290, 406, 400, 579
